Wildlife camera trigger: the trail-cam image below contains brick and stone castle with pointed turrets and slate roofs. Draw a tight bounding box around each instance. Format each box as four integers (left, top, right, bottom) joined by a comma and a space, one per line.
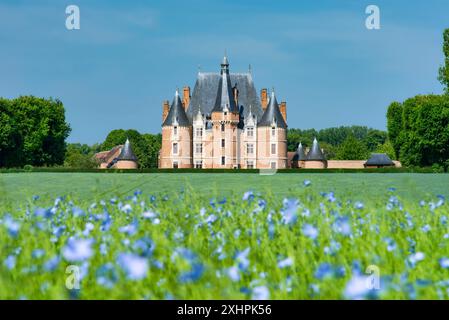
159, 56, 288, 169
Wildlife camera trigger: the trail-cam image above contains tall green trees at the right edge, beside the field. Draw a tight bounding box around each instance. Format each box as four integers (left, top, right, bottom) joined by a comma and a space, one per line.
387, 29, 449, 170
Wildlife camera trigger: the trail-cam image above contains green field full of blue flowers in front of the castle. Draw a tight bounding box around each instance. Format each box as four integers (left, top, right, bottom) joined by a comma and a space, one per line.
0, 173, 449, 299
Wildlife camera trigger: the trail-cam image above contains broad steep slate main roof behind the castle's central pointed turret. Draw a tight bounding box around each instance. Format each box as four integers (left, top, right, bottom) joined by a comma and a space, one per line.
187, 72, 263, 121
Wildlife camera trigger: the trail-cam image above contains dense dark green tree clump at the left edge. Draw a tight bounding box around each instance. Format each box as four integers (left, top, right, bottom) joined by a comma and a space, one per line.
0, 96, 70, 167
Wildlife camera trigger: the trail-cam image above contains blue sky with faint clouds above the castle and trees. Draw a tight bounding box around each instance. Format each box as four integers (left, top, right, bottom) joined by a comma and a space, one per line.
0, 0, 449, 144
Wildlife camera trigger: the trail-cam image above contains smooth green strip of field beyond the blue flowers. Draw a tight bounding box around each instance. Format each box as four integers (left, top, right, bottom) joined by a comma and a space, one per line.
0, 173, 449, 204
